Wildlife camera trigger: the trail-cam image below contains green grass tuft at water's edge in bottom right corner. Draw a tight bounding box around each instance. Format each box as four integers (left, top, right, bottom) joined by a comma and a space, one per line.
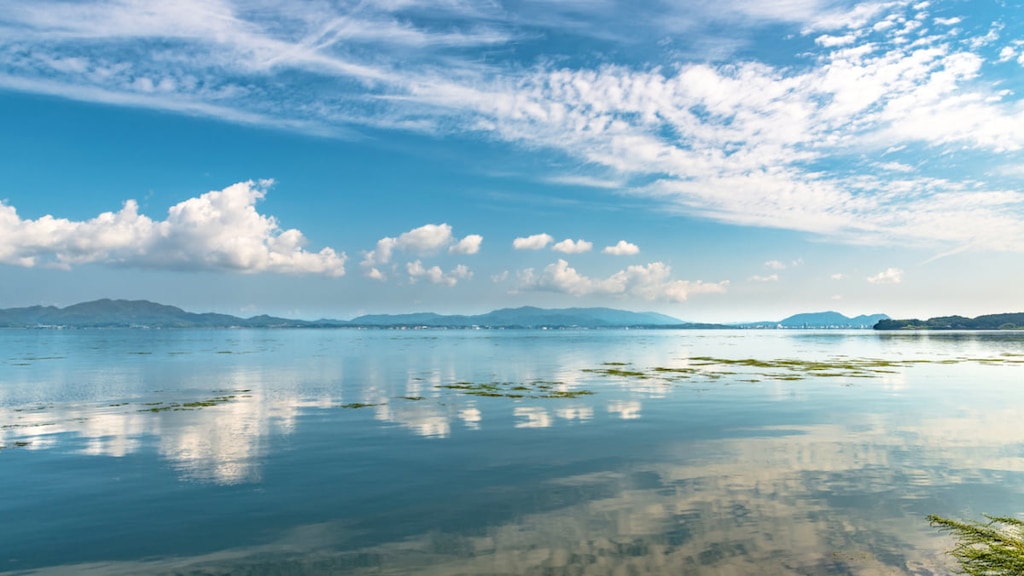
928, 515, 1024, 576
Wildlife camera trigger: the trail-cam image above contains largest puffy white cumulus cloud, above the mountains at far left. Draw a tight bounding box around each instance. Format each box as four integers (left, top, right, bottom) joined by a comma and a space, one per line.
0, 180, 346, 277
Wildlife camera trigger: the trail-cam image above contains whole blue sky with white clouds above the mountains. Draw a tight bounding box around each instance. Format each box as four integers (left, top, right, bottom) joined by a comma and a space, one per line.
0, 0, 1024, 322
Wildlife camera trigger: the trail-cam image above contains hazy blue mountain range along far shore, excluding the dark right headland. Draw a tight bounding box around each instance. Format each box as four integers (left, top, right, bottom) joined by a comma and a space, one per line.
0, 299, 889, 328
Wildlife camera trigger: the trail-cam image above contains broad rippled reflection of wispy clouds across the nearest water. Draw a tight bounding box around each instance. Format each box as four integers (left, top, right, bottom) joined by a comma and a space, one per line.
16, 408, 1024, 576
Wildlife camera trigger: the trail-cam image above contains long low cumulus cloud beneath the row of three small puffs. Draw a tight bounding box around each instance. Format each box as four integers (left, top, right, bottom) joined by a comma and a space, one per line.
519, 258, 729, 302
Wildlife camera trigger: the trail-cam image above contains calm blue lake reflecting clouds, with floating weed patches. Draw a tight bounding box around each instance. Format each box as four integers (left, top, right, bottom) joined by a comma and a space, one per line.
0, 329, 1024, 575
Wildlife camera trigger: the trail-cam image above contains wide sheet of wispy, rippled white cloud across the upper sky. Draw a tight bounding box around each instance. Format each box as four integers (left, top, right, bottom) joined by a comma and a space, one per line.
6, 0, 1024, 253
